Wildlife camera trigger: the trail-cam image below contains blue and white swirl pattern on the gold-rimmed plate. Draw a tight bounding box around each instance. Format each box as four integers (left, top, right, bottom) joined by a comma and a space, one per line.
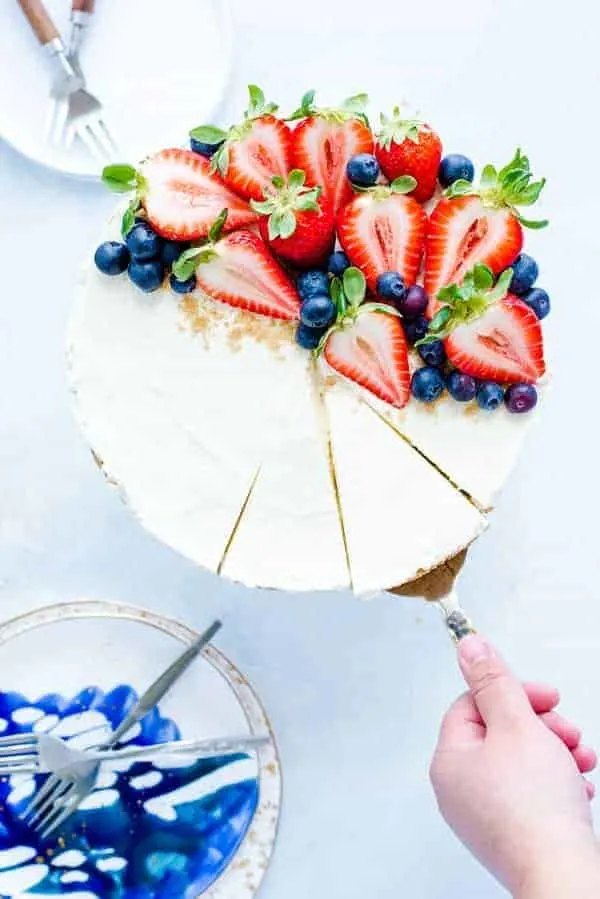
0, 684, 258, 899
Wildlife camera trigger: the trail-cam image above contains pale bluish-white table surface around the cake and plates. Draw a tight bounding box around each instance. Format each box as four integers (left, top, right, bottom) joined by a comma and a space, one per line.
0, 0, 600, 899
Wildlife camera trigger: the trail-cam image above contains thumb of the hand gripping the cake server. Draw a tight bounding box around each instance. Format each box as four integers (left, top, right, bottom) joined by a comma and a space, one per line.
458, 634, 533, 727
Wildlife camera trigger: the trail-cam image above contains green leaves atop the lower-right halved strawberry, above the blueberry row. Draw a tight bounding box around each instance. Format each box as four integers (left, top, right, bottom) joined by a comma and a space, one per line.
416, 264, 513, 346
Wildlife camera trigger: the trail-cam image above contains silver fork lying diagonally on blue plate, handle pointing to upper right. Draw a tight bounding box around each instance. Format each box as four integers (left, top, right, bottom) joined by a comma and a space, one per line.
22, 621, 221, 838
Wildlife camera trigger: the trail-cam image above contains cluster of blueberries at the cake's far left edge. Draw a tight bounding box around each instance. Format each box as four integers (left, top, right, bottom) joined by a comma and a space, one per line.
94, 217, 196, 294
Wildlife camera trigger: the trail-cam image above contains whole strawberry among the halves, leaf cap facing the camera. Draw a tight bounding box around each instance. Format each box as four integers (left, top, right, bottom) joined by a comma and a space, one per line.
250, 169, 335, 267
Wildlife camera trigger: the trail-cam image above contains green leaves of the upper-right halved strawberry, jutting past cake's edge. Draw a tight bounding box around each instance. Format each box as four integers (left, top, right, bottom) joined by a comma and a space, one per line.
445, 149, 548, 229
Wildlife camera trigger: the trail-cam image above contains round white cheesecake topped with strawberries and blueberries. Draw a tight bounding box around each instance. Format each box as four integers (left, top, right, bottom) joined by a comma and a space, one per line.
69, 86, 549, 595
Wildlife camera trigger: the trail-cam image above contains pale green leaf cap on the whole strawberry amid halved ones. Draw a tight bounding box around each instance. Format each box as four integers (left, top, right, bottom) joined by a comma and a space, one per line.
250, 169, 321, 240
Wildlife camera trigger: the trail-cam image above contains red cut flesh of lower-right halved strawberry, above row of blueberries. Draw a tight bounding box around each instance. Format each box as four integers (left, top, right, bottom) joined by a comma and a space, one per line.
445, 294, 546, 384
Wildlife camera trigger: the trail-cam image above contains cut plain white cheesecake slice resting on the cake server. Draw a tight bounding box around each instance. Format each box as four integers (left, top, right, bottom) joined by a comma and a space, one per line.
324, 383, 486, 594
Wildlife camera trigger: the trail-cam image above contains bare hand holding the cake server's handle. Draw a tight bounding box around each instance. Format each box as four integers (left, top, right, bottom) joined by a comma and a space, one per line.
431, 636, 600, 897
